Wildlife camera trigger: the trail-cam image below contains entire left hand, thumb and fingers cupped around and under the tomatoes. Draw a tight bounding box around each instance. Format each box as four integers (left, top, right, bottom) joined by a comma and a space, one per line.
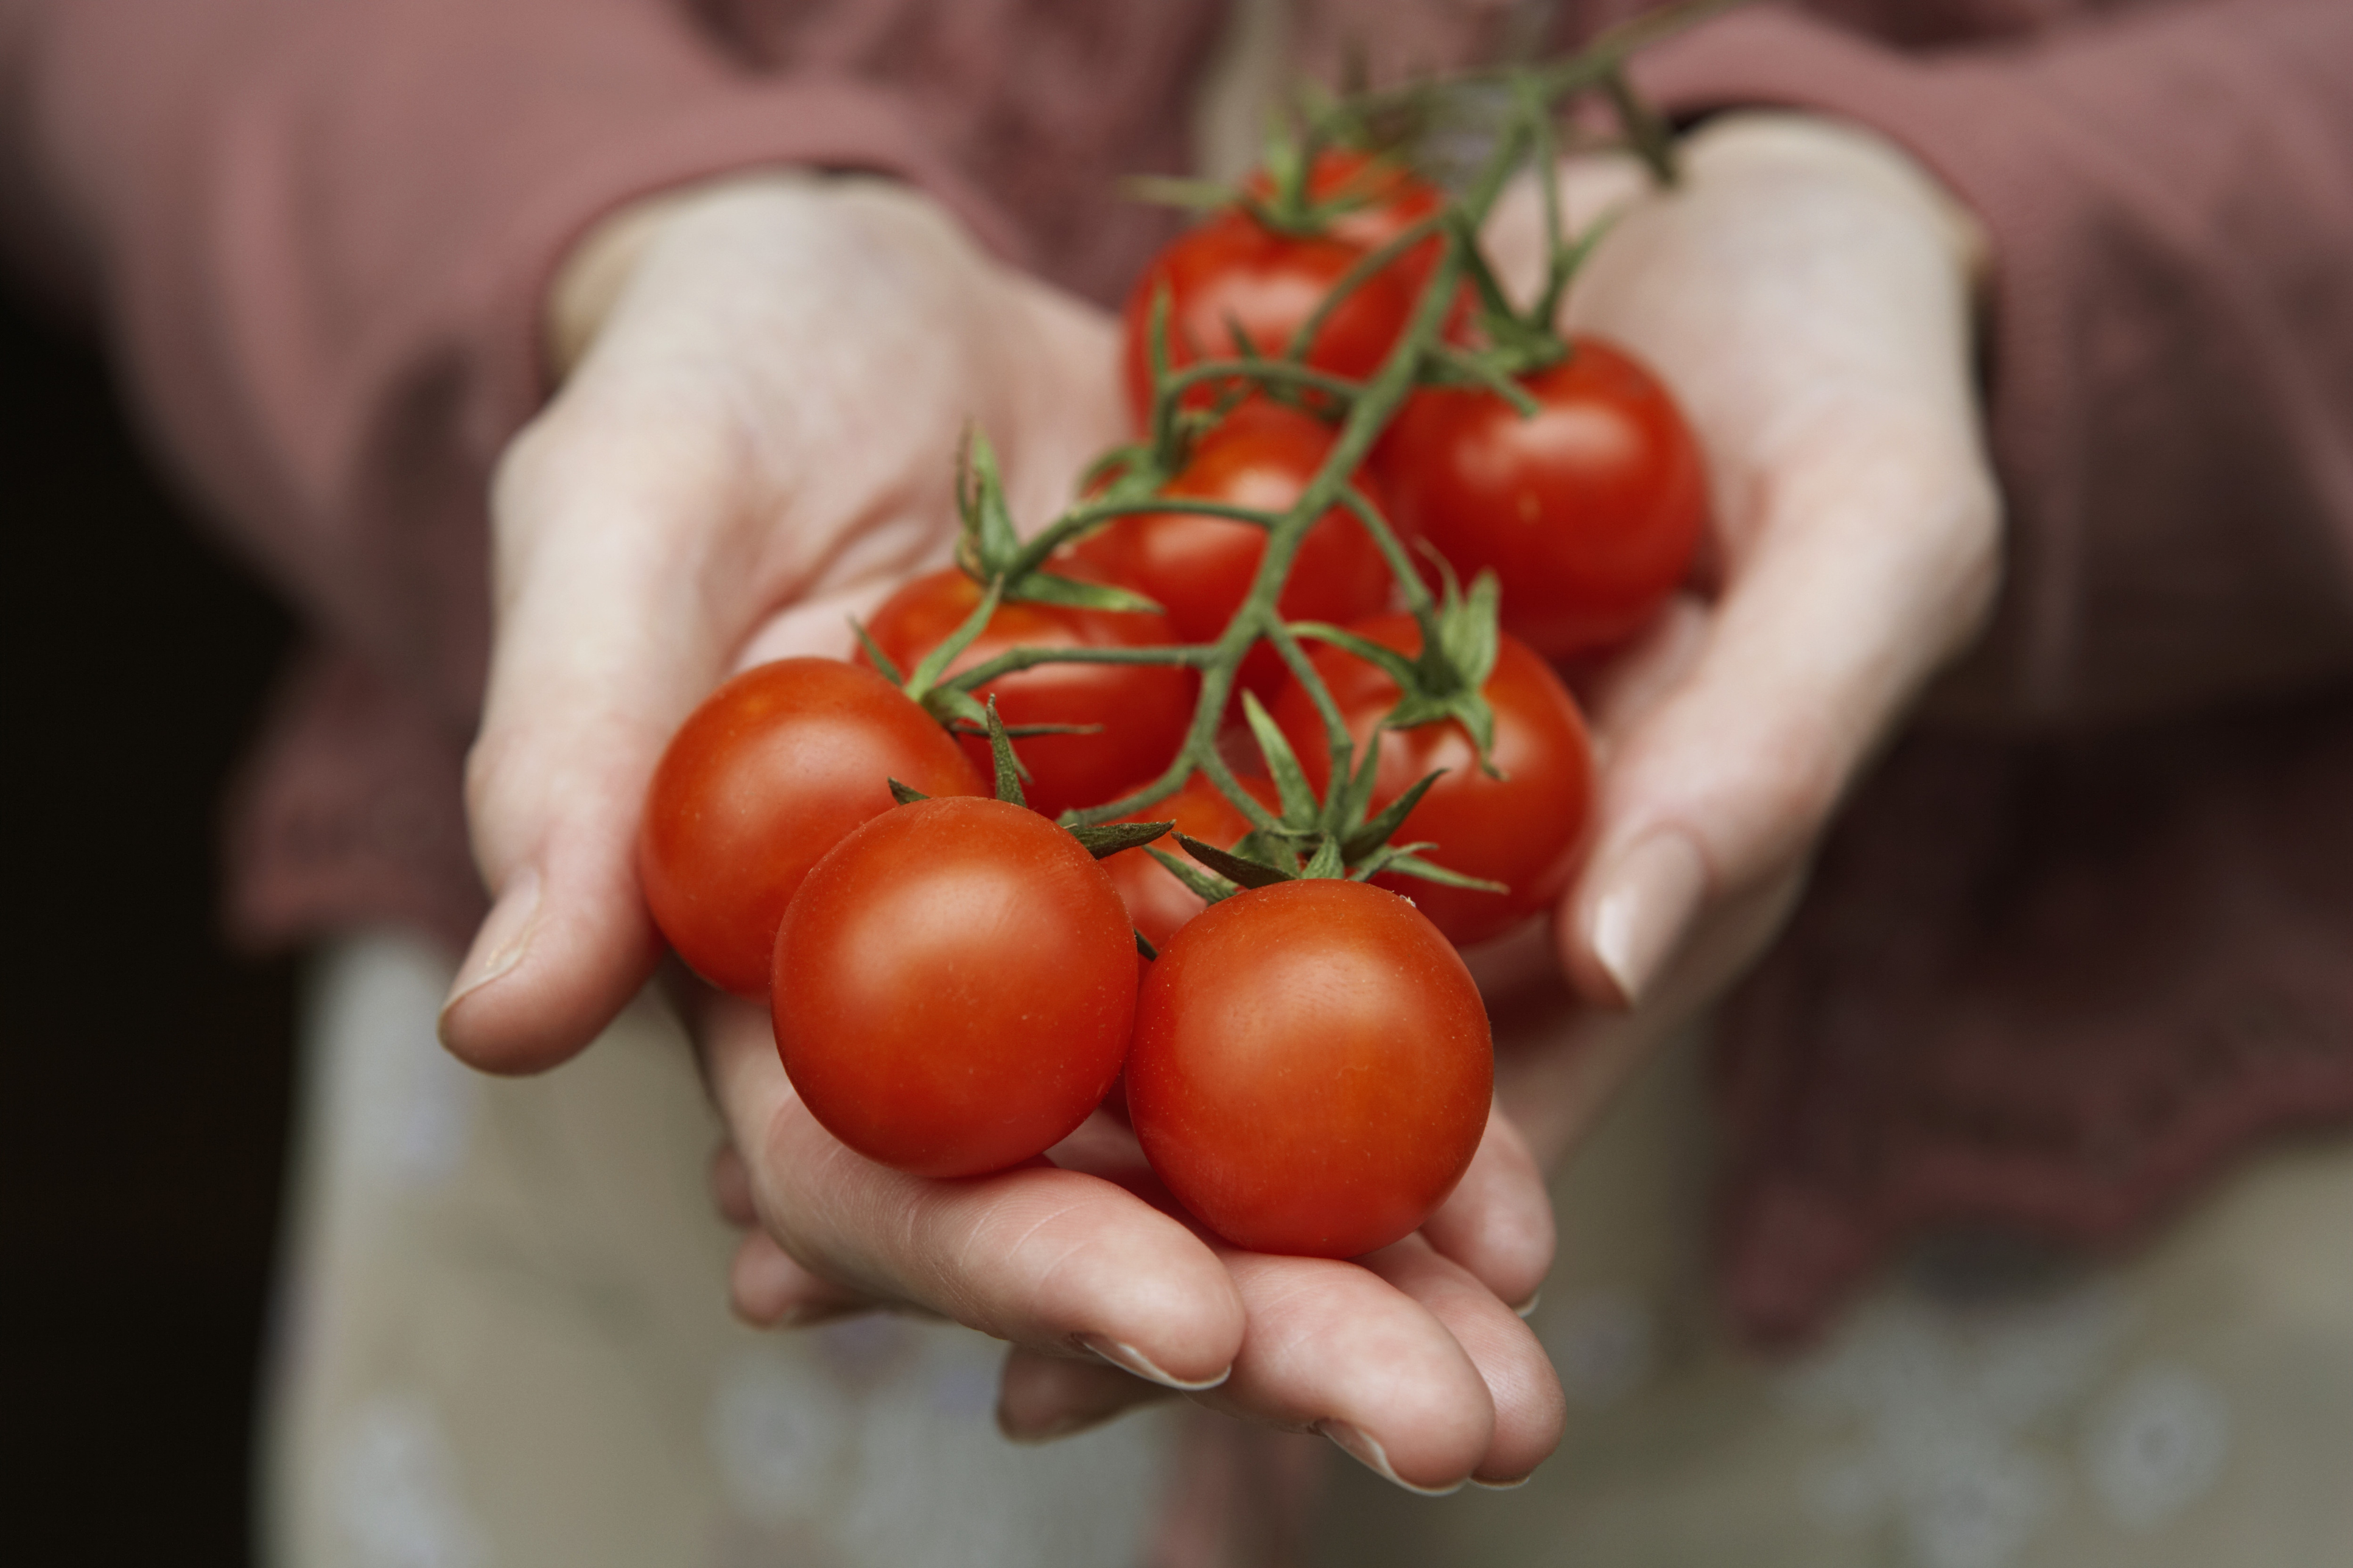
443, 177, 1560, 1488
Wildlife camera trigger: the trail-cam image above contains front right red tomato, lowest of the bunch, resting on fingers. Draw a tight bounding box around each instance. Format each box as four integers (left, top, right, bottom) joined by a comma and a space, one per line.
1127, 881, 1494, 1257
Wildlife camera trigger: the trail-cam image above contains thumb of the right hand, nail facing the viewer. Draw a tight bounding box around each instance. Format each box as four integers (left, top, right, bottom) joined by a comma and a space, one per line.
1558, 424, 1997, 1003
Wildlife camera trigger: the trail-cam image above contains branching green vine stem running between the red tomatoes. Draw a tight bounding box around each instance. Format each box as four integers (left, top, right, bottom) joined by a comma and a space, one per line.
889, 12, 1736, 861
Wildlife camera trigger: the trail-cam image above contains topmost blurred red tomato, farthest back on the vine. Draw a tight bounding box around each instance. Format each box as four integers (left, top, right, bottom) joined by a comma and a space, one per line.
1123, 209, 1414, 426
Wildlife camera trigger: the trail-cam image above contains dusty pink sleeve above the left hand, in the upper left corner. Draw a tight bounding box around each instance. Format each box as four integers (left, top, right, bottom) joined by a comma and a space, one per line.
0, 0, 1068, 725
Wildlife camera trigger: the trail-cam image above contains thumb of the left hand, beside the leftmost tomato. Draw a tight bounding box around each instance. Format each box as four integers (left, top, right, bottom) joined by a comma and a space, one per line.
443, 388, 727, 1071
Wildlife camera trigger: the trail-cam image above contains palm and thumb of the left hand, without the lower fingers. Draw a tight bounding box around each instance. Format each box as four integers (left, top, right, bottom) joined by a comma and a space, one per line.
443, 174, 1120, 1071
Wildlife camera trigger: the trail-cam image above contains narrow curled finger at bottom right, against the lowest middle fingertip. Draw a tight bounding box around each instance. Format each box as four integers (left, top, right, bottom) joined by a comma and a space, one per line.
1358, 1236, 1567, 1486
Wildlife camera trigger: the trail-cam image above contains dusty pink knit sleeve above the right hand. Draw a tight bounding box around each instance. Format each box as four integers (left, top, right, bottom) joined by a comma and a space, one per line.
1640, 0, 2353, 718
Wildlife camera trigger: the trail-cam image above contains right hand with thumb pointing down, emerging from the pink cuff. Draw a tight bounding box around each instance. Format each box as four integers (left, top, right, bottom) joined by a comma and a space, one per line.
1490, 113, 2000, 1156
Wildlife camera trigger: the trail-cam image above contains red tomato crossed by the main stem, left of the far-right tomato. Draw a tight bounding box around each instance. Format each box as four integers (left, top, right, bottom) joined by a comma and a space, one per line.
1073, 398, 1390, 697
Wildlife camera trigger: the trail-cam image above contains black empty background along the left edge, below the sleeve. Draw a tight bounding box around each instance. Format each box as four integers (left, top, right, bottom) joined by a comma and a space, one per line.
0, 287, 296, 1568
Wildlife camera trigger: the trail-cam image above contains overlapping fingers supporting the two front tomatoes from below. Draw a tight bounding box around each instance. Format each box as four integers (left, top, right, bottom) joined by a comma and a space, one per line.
704, 998, 1565, 1490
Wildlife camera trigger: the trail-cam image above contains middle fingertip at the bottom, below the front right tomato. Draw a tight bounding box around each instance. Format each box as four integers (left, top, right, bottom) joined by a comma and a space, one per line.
1195, 1250, 1510, 1493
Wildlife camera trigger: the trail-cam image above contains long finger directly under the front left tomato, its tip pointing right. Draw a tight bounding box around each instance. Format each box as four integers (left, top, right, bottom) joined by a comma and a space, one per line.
706, 1001, 1243, 1387
